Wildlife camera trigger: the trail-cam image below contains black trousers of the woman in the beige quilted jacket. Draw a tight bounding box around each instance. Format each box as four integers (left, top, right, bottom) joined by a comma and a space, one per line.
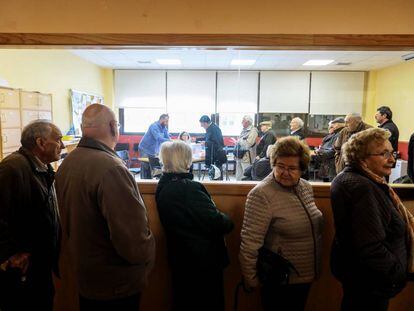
261, 283, 311, 311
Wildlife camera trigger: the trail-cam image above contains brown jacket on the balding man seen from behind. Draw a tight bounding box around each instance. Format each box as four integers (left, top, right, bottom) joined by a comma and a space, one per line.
56, 137, 155, 300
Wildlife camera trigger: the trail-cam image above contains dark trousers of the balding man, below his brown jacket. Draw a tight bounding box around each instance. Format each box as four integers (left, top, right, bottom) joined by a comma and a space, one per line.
79, 293, 141, 311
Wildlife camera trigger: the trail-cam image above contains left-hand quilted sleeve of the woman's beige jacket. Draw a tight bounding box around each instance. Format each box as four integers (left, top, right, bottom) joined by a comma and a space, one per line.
239, 189, 272, 287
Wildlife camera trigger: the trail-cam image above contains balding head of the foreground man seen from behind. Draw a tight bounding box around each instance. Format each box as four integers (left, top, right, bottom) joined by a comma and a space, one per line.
82, 104, 119, 149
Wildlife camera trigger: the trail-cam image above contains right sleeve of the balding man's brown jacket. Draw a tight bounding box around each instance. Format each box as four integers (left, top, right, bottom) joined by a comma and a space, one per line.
98, 166, 155, 265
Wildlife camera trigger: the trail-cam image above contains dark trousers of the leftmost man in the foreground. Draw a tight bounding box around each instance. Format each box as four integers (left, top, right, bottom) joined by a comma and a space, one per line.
0, 268, 55, 311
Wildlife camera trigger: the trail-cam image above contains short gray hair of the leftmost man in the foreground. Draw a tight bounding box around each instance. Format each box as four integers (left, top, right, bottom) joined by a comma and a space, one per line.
20, 120, 57, 150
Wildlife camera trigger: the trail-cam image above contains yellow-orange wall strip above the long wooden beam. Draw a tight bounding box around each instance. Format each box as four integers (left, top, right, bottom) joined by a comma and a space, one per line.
0, 0, 414, 34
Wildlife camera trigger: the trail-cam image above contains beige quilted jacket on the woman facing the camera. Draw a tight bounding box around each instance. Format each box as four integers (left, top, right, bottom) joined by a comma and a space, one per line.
239, 173, 323, 287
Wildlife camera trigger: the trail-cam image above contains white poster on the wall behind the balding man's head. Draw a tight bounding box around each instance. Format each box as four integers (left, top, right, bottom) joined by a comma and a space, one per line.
68, 89, 104, 136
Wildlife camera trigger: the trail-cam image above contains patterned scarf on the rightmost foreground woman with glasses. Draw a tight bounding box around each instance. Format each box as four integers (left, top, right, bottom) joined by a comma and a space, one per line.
360, 164, 414, 273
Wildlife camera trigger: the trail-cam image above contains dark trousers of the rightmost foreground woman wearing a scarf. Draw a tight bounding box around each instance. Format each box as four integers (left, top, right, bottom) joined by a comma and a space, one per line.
341, 285, 389, 311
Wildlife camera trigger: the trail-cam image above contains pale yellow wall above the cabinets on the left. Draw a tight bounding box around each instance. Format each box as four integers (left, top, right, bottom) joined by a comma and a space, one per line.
0, 49, 113, 133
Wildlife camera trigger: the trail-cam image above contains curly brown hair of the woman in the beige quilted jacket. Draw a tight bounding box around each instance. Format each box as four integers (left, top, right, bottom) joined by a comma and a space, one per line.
270, 136, 310, 171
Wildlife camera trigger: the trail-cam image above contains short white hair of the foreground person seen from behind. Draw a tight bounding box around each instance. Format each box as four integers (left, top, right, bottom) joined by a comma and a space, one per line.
160, 141, 193, 173
